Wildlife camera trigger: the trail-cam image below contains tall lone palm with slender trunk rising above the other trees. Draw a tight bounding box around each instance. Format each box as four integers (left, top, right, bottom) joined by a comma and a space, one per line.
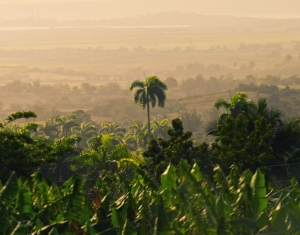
129, 76, 167, 141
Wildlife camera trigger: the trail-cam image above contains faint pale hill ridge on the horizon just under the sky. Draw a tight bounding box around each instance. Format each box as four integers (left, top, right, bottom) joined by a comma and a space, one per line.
0, 12, 300, 30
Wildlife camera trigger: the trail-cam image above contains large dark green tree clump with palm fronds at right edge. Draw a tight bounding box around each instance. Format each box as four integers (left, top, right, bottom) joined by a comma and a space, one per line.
207, 93, 300, 181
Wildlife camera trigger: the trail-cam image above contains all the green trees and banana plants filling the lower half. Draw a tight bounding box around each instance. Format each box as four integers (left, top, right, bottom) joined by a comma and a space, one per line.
0, 87, 300, 234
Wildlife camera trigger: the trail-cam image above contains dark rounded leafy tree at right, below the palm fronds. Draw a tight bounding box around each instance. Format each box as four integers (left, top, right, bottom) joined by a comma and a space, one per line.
211, 115, 274, 174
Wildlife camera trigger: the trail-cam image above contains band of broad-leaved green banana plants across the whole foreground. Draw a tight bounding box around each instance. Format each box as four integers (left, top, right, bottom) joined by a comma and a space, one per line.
4, 160, 300, 235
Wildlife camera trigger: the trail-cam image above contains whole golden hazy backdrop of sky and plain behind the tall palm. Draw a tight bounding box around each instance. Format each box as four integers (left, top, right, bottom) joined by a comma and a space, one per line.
0, 0, 300, 125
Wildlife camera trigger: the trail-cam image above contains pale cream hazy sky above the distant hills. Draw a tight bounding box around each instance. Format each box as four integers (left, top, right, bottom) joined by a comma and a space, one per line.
0, 0, 300, 19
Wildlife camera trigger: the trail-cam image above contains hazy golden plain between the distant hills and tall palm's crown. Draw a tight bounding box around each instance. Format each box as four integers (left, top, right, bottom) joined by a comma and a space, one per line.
0, 27, 300, 82
